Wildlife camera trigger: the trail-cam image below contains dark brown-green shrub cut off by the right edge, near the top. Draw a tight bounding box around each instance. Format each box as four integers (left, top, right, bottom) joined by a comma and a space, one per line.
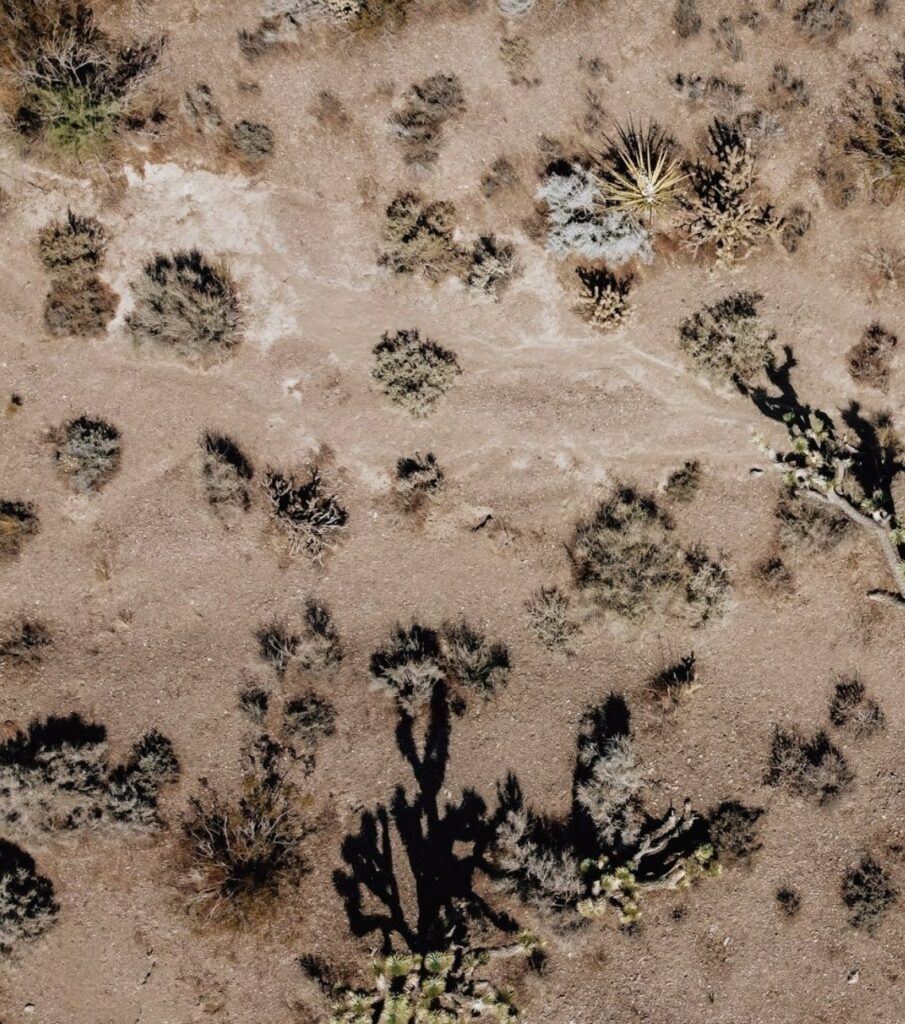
839, 52, 905, 194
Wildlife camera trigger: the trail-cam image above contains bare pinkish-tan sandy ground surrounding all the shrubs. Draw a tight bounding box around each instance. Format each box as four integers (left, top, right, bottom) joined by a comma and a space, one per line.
0, 0, 905, 1024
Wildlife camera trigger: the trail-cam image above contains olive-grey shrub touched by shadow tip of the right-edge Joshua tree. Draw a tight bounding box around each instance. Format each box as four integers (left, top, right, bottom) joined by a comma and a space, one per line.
679, 292, 776, 384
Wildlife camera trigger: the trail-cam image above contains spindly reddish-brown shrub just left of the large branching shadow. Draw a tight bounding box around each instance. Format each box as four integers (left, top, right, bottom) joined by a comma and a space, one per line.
182, 741, 310, 923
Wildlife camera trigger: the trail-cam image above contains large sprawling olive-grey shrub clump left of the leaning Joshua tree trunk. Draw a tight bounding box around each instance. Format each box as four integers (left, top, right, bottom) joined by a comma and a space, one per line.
569, 483, 729, 624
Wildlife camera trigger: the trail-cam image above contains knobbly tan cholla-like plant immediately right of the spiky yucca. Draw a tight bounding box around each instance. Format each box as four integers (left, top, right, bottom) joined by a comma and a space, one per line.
681, 118, 782, 261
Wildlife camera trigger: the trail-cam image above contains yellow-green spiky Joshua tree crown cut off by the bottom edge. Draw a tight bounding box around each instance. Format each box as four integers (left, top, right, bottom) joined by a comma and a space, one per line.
330, 933, 537, 1024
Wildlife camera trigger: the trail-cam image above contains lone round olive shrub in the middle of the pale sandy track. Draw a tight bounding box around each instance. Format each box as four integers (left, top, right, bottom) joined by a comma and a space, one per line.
372, 330, 462, 416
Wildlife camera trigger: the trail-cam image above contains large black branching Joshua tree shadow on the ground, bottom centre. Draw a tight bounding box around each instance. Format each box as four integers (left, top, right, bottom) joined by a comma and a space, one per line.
334, 686, 518, 953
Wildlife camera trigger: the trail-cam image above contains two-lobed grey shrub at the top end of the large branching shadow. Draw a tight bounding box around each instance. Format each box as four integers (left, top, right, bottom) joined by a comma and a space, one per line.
371, 621, 510, 717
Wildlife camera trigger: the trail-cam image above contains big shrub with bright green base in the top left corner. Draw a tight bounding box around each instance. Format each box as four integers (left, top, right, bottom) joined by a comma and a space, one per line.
0, 0, 163, 158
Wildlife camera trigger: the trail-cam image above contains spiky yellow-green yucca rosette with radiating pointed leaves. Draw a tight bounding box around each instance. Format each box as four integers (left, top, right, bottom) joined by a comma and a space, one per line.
597, 121, 687, 223
